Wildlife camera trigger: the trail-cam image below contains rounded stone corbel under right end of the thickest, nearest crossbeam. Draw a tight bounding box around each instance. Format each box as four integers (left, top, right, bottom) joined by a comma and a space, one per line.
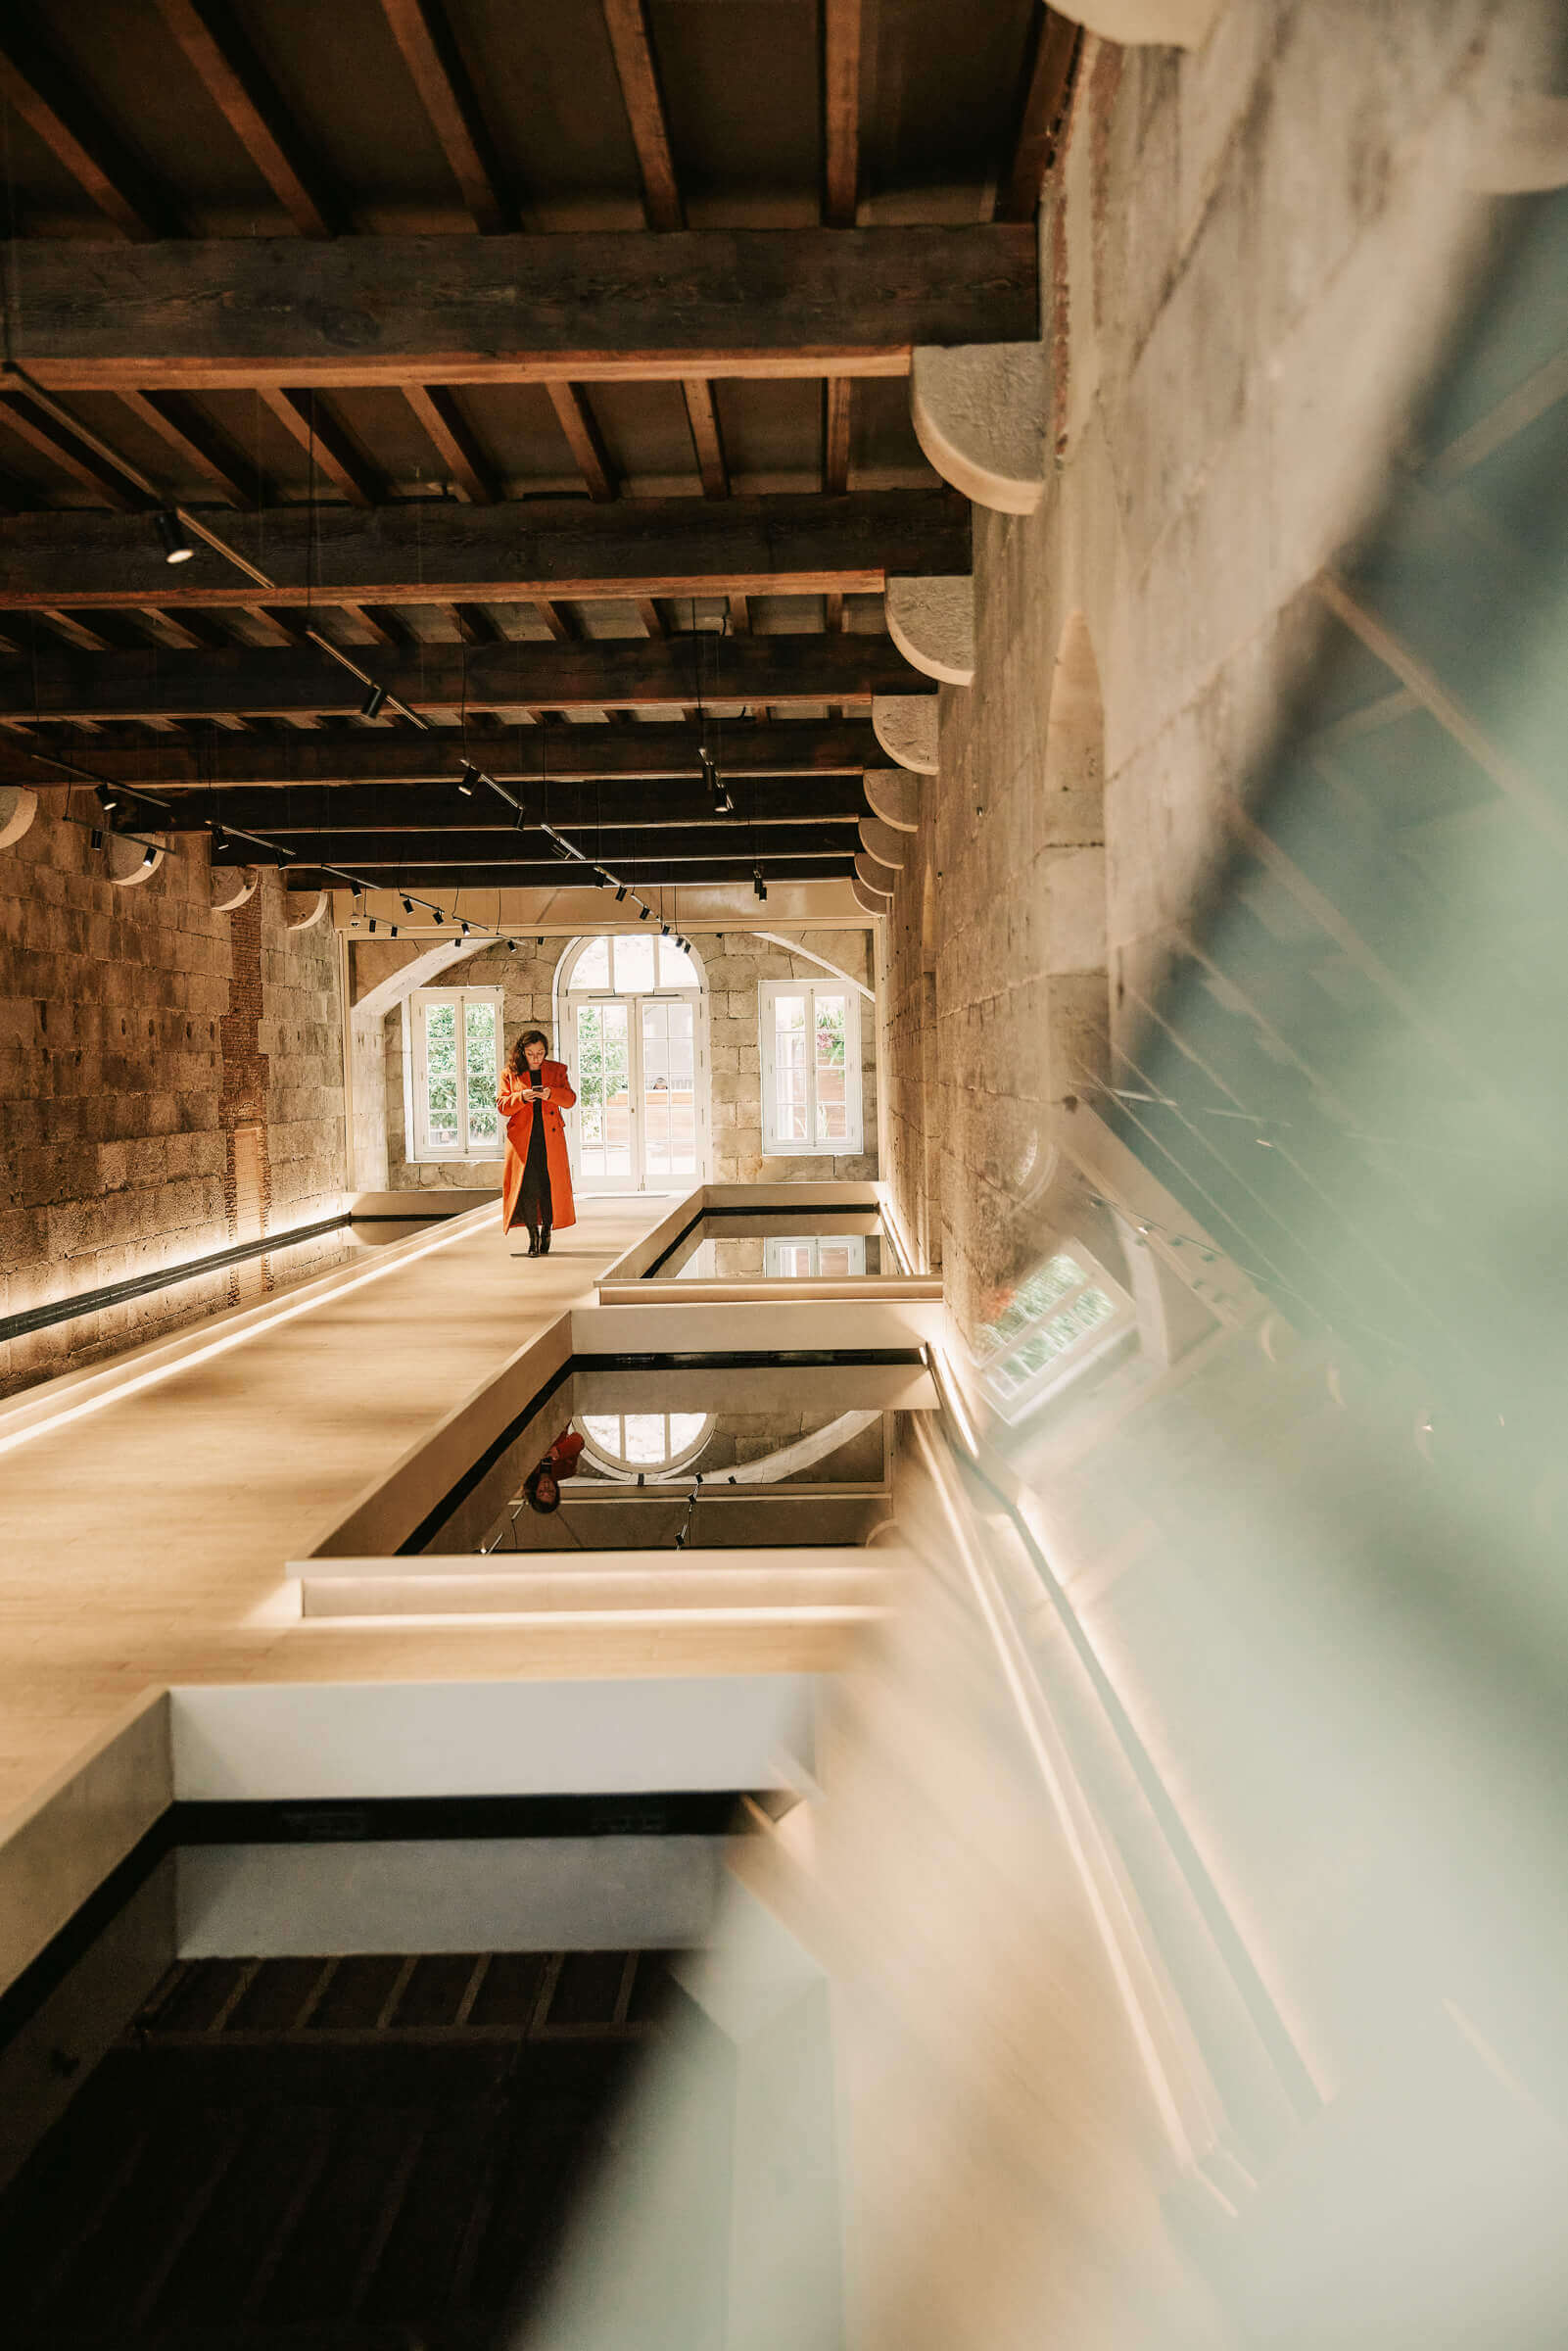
910, 343, 1051, 517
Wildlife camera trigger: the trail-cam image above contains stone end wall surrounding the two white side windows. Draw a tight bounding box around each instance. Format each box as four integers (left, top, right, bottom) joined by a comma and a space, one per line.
376, 931, 877, 1189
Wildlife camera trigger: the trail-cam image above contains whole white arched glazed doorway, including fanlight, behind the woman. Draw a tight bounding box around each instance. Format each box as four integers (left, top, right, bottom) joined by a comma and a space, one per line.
554, 929, 710, 1192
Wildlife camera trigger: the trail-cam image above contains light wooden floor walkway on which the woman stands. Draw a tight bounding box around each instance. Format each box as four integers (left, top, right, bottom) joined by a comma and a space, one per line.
0, 1199, 846, 1834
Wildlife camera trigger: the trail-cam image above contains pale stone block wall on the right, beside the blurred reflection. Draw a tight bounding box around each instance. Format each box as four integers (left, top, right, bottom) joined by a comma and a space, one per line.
886, 0, 1533, 1328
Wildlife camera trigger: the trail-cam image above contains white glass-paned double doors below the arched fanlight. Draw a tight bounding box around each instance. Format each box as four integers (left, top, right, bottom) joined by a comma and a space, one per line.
566, 989, 707, 1192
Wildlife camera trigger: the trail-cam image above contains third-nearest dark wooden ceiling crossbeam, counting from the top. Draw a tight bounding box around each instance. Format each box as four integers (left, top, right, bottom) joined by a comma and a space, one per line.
0, 635, 935, 719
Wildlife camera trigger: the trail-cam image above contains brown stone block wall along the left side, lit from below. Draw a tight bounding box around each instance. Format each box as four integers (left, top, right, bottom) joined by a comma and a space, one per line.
0, 790, 343, 1394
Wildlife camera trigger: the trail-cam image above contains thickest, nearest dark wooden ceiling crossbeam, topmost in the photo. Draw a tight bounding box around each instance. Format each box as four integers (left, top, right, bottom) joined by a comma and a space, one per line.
10, 221, 1039, 390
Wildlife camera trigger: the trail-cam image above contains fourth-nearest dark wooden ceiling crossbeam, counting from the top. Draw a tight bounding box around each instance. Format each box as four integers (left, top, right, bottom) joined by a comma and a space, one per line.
0, 714, 886, 792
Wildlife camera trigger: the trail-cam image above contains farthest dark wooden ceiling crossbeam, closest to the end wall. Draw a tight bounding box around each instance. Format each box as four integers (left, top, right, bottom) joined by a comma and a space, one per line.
214, 823, 861, 880
